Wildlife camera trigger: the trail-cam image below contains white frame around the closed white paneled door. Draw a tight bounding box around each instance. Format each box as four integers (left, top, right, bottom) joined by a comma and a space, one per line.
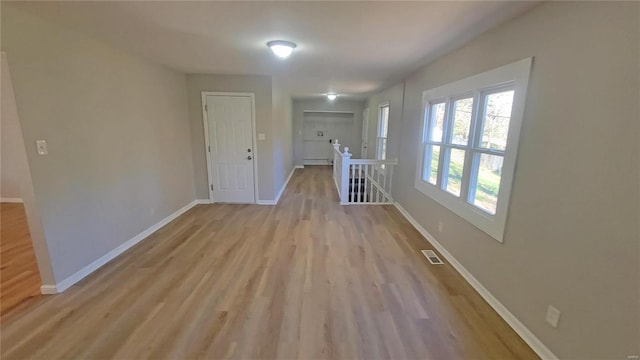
201, 91, 260, 204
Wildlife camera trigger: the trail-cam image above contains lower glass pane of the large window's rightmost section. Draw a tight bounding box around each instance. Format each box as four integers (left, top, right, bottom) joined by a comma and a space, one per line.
472, 154, 504, 215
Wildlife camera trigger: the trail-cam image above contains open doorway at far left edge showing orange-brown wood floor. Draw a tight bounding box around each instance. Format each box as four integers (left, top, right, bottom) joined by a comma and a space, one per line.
0, 52, 44, 321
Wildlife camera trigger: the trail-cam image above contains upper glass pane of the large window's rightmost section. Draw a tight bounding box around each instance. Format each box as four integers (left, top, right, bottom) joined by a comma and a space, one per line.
480, 90, 514, 150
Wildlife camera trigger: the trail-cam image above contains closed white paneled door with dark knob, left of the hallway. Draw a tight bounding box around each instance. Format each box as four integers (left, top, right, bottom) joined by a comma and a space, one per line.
206, 95, 255, 203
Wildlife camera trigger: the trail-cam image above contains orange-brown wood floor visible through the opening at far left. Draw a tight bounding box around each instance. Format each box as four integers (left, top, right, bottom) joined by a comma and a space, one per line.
0, 203, 41, 321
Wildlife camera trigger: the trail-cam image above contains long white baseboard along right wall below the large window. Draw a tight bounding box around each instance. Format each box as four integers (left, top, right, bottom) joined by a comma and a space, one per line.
394, 202, 558, 360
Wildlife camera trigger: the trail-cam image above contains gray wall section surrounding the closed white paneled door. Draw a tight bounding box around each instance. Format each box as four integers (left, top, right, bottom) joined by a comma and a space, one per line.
187, 74, 275, 200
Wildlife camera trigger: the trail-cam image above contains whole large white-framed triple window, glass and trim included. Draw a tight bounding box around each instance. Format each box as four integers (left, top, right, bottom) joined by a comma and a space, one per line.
415, 58, 532, 242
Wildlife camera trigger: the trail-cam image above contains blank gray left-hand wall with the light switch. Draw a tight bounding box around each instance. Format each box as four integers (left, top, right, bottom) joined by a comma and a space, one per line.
2, 3, 195, 285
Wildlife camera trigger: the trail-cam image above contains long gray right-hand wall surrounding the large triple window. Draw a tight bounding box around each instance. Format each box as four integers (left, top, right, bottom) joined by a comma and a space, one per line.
374, 2, 640, 359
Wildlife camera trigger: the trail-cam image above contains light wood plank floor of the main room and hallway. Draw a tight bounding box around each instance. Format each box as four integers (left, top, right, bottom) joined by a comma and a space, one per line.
1, 167, 537, 360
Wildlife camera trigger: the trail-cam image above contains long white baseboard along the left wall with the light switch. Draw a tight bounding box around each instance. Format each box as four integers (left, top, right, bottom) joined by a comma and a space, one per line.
40, 200, 200, 294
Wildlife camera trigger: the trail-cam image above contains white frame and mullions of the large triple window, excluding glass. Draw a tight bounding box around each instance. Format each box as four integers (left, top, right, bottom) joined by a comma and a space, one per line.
415, 58, 533, 243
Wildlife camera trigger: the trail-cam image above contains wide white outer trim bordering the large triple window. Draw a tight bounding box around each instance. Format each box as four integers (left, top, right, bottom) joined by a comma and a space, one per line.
415, 58, 533, 242
